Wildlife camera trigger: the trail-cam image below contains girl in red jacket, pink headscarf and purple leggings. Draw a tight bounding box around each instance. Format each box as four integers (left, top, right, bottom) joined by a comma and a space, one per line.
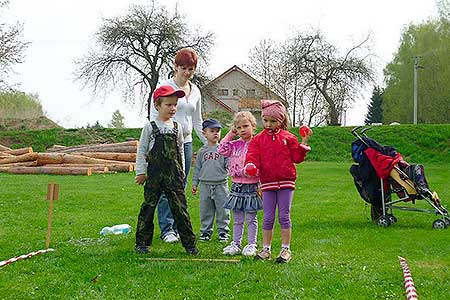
245, 100, 311, 263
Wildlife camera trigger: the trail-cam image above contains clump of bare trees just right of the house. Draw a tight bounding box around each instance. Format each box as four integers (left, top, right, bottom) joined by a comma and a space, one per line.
249, 30, 374, 125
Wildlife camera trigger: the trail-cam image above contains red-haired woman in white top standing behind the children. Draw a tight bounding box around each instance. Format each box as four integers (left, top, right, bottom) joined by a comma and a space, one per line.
150, 48, 206, 243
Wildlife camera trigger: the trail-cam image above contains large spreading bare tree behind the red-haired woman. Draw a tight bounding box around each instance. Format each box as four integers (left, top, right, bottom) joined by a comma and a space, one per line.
75, 0, 214, 117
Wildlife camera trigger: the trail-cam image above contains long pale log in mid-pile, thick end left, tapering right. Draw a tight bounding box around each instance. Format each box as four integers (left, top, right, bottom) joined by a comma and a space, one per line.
35, 152, 134, 166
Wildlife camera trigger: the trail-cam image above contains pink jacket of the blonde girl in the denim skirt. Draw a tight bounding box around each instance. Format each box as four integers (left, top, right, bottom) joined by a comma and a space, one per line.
217, 131, 259, 184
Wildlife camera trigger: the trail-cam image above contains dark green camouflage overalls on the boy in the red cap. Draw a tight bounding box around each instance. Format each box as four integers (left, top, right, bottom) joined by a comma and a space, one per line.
136, 122, 195, 249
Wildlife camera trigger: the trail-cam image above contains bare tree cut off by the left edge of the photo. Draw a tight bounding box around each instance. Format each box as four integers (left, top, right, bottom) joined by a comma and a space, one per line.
0, 0, 28, 89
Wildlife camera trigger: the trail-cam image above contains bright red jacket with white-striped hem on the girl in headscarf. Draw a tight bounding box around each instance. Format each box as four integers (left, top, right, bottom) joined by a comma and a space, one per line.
245, 129, 311, 191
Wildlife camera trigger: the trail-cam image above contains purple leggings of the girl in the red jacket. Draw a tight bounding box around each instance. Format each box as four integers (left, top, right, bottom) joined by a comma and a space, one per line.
263, 189, 294, 230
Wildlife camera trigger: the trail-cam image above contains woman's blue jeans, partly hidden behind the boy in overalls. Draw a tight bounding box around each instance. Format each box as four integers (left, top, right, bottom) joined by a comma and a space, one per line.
158, 142, 193, 238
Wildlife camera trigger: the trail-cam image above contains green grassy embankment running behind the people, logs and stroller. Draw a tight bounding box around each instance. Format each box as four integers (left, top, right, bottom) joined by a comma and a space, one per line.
0, 124, 450, 163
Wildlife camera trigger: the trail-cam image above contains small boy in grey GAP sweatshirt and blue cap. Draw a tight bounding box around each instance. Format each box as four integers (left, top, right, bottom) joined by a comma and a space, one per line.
192, 119, 230, 242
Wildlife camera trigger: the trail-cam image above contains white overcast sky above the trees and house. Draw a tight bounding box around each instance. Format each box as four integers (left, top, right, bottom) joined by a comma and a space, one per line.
2, 0, 436, 128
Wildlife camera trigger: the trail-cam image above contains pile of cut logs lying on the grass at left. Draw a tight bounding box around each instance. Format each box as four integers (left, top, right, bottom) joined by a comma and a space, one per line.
0, 140, 138, 176
